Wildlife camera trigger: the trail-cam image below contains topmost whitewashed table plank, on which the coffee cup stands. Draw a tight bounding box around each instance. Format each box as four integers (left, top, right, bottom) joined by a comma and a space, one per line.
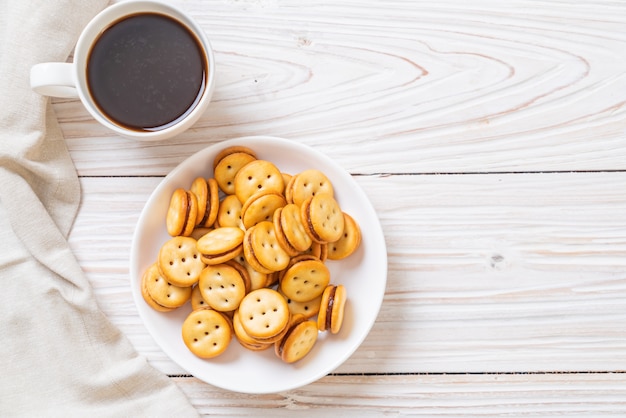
55, 0, 626, 175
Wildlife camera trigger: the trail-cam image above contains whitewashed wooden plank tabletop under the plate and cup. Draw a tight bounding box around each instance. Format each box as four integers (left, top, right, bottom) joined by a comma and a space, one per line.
54, 0, 626, 417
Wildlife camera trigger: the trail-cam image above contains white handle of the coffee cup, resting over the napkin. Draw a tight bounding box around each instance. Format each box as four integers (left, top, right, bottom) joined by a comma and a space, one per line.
30, 62, 78, 98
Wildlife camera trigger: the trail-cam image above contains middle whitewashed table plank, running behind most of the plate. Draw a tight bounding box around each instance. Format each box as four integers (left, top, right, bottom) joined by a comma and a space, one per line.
70, 173, 626, 374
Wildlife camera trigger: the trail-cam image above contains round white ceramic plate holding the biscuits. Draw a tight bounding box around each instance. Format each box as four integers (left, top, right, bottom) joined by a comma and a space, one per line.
130, 137, 387, 394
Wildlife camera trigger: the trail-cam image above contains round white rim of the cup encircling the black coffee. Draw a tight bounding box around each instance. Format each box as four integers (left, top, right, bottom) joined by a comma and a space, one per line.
72, 0, 215, 141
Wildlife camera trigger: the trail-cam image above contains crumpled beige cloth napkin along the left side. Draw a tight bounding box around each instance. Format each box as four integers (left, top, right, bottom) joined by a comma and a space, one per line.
0, 0, 197, 417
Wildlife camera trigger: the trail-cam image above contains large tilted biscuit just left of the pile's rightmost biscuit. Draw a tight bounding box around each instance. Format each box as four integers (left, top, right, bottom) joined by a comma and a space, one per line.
300, 194, 344, 244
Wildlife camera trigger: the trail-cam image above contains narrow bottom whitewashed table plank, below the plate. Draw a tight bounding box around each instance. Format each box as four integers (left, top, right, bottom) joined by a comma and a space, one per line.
175, 374, 626, 417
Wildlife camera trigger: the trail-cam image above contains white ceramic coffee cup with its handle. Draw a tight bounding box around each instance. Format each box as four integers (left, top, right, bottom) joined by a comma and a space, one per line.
30, 0, 215, 141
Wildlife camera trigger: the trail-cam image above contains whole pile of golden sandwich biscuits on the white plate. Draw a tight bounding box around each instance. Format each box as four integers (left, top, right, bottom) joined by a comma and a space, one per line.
141, 146, 361, 363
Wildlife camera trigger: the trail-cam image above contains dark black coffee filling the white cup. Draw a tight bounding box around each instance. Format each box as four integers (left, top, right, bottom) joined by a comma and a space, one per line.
87, 13, 208, 131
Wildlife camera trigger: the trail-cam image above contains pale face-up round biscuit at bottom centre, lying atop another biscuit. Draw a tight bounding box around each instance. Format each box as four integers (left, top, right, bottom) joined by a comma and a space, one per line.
239, 288, 290, 338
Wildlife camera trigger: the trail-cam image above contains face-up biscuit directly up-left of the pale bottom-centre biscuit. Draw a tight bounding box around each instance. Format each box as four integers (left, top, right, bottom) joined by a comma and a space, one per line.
198, 264, 246, 312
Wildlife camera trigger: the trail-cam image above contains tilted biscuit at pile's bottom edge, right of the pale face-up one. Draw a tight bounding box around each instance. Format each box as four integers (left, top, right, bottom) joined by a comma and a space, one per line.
274, 315, 319, 363
